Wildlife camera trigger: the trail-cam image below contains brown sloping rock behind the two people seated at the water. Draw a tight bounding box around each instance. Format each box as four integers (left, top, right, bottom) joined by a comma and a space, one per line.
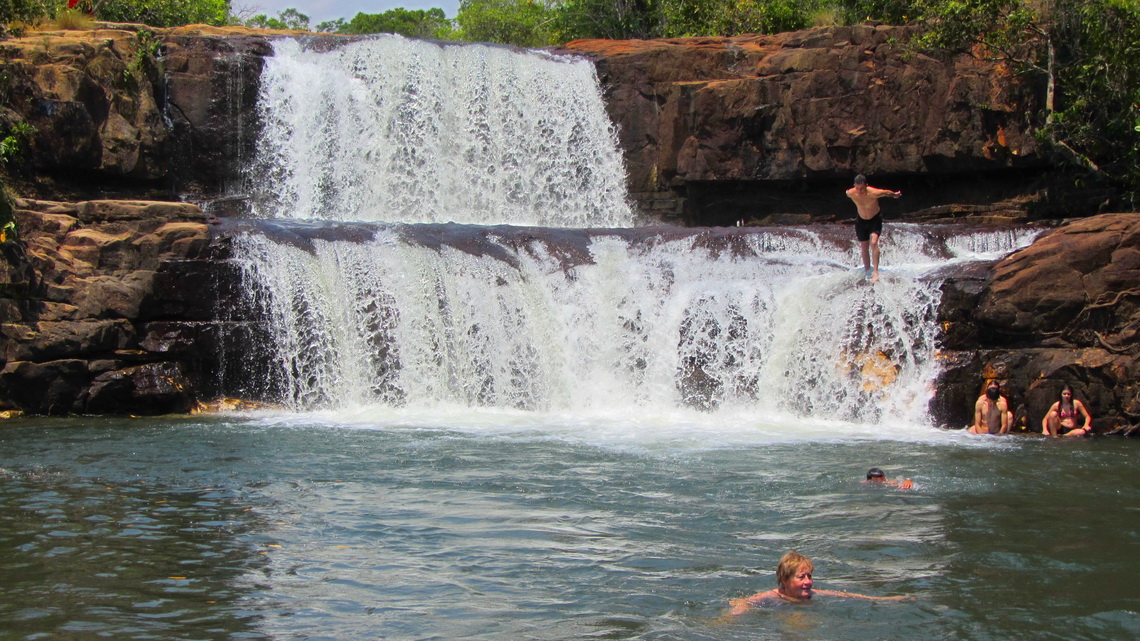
934, 213, 1140, 431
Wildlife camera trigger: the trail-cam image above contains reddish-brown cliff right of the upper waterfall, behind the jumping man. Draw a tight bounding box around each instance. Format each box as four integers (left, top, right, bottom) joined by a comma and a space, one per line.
564, 25, 1044, 224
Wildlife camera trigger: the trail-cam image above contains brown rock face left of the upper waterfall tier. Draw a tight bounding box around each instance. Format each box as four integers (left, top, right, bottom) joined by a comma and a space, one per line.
0, 23, 271, 200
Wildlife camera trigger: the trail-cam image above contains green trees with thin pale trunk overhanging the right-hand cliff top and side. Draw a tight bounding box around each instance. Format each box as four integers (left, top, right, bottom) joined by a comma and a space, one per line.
915, 0, 1140, 197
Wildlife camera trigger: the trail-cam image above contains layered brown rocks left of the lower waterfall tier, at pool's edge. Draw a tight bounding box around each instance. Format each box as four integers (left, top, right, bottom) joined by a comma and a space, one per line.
0, 201, 218, 414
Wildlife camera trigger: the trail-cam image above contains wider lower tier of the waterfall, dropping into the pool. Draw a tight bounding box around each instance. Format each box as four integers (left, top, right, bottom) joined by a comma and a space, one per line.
220, 222, 1032, 423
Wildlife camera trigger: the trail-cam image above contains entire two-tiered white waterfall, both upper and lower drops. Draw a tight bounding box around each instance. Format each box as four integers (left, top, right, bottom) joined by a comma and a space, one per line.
235, 36, 1032, 424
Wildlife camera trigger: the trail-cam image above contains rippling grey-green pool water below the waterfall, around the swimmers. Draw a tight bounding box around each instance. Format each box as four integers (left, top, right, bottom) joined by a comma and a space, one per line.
0, 407, 1140, 641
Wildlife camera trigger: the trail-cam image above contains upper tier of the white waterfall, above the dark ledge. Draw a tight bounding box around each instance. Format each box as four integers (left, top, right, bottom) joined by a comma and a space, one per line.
247, 35, 633, 227
